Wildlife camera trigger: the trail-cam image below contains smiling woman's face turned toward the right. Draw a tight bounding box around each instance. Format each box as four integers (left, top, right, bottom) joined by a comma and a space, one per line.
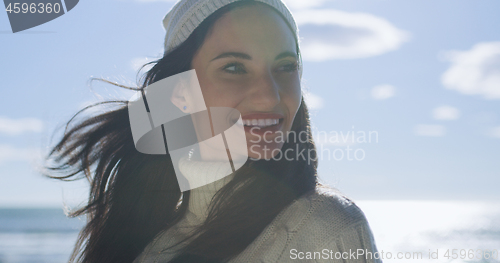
188, 4, 301, 159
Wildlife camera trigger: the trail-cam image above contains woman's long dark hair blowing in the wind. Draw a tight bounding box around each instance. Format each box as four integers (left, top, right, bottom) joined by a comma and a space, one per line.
46, 1, 318, 263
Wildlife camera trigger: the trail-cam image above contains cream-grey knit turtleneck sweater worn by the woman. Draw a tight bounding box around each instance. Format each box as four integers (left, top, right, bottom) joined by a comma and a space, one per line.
133, 158, 382, 263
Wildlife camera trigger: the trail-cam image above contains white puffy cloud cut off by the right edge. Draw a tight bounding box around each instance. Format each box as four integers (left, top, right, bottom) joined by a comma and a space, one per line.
441, 42, 500, 99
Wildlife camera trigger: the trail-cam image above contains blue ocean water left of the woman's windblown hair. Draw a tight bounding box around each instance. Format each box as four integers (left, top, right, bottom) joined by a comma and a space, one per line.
0, 208, 85, 263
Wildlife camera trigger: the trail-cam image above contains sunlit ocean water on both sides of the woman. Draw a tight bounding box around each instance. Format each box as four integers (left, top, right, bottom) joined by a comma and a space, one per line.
0, 201, 500, 263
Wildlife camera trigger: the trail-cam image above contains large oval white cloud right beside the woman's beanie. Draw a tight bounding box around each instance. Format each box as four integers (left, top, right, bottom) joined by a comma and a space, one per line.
294, 9, 409, 61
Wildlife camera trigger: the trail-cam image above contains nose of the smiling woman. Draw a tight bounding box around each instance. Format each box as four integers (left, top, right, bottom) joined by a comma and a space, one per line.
248, 72, 281, 111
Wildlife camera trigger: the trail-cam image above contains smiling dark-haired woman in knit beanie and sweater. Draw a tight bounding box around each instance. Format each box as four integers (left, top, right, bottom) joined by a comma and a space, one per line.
49, 0, 380, 262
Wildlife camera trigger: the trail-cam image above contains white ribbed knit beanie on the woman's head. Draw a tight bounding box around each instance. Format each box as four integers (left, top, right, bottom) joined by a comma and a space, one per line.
163, 0, 298, 54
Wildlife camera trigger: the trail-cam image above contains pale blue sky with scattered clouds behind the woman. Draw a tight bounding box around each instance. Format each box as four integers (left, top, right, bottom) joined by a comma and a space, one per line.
0, 0, 500, 206
